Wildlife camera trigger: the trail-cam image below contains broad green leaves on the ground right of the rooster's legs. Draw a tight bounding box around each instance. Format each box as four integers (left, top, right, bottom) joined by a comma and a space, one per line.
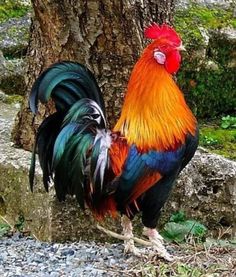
162, 211, 207, 242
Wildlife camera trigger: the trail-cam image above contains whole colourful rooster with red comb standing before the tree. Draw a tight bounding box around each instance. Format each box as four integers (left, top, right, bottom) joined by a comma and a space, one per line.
29, 24, 198, 260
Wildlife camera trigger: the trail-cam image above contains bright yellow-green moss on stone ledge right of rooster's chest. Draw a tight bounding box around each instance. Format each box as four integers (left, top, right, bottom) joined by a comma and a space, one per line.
200, 125, 236, 160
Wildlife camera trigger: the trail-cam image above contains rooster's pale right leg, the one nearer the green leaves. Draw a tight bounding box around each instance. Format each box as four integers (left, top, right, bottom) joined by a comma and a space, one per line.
143, 227, 173, 261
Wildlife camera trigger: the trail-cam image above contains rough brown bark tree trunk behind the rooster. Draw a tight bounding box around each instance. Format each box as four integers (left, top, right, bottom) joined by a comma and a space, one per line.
12, 0, 175, 149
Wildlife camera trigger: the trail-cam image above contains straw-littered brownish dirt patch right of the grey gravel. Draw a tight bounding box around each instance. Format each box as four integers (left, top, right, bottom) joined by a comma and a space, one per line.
101, 244, 236, 277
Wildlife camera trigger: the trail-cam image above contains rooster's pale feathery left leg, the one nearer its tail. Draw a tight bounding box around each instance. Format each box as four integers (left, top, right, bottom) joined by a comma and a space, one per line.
121, 215, 141, 256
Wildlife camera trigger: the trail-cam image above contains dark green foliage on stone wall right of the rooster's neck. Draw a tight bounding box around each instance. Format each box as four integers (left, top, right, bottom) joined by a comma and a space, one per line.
178, 67, 236, 118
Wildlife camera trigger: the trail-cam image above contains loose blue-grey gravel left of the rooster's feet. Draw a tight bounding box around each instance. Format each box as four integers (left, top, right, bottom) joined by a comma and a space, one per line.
0, 234, 137, 277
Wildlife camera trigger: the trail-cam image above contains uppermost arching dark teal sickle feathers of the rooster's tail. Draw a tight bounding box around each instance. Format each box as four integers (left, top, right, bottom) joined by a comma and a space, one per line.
29, 61, 105, 113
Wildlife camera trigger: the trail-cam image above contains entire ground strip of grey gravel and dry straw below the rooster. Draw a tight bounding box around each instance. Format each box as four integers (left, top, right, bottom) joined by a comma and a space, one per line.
0, 233, 236, 277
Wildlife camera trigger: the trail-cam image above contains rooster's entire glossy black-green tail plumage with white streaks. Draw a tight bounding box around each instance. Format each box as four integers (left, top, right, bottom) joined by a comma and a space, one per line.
29, 62, 110, 209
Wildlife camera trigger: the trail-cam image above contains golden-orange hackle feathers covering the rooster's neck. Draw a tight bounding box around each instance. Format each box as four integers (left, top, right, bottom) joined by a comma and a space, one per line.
114, 48, 196, 151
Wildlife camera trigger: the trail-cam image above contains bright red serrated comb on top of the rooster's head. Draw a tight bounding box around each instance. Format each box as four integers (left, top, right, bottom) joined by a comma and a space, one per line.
144, 23, 181, 44
